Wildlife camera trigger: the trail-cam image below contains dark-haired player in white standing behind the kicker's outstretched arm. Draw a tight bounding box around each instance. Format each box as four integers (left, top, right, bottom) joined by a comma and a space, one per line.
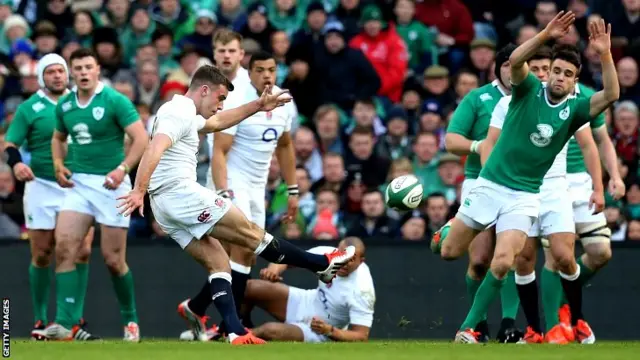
209, 52, 298, 338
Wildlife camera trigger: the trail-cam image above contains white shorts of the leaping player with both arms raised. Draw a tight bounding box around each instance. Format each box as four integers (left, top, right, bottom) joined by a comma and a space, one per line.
458, 177, 540, 233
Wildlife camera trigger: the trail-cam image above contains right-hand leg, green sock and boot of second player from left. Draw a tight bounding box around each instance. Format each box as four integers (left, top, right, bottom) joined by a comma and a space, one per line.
100, 224, 140, 342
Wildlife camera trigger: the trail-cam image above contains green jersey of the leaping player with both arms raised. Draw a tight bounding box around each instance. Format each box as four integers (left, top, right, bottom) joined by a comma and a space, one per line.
480, 73, 591, 193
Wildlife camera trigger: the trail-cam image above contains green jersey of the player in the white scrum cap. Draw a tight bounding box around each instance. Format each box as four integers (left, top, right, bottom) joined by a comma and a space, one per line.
5, 90, 69, 181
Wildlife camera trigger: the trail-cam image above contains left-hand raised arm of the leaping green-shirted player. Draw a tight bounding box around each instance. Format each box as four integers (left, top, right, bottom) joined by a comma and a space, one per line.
509, 11, 576, 85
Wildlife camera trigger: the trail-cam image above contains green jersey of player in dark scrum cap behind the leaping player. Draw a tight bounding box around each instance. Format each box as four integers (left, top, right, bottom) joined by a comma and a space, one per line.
447, 80, 505, 179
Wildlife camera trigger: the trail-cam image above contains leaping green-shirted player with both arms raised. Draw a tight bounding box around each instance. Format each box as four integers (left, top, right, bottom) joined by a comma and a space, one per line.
435, 12, 620, 343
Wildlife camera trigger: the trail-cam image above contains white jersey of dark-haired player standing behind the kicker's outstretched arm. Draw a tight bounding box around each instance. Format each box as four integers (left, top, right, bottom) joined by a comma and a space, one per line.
222, 86, 297, 187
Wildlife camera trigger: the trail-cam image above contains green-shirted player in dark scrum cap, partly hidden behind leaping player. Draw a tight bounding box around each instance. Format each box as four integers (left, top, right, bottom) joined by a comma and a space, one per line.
442, 44, 520, 342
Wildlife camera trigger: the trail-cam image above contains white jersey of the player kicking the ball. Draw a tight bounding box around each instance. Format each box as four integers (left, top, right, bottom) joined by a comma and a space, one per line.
149, 95, 206, 194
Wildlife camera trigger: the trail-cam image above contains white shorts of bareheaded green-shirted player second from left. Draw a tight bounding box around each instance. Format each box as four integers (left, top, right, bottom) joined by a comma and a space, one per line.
60, 174, 131, 228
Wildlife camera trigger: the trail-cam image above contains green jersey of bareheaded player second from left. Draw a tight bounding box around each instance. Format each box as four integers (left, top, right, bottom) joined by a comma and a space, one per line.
56, 82, 139, 175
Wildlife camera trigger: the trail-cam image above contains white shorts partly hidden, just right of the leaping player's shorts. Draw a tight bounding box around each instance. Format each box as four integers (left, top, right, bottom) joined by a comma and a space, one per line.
529, 177, 576, 237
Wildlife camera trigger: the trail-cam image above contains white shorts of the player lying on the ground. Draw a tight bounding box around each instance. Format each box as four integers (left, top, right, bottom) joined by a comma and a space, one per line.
285, 286, 330, 343
